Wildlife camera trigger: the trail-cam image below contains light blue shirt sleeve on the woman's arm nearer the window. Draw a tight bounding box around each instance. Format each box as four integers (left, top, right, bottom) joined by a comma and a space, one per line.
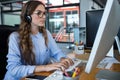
47, 30, 67, 61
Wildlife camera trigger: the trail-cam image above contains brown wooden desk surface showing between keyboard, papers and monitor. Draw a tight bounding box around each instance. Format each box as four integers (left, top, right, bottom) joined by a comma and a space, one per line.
22, 54, 120, 80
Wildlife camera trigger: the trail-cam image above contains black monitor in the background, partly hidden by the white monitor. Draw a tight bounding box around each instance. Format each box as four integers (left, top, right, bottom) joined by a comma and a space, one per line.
85, 9, 103, 49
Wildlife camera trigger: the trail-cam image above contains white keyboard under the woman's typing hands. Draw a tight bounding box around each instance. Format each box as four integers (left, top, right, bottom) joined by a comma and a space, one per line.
44, 59, 86, 80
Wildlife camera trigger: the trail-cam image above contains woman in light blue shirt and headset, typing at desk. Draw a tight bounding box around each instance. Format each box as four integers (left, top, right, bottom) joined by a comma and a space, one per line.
4, 1, 73, 80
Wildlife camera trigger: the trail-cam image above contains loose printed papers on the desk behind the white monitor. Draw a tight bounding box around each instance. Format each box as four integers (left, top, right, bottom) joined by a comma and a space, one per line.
97, 57, 120, 69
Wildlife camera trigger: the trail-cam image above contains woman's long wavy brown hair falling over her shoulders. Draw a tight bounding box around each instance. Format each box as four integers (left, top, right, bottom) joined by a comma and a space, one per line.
18, 1, 48, 65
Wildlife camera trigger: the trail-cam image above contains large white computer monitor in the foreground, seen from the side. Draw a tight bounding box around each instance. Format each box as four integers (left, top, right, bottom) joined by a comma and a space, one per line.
85, 0, 120, 73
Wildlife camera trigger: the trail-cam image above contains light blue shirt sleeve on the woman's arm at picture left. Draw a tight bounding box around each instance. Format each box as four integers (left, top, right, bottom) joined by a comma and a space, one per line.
7, 32, 35, 78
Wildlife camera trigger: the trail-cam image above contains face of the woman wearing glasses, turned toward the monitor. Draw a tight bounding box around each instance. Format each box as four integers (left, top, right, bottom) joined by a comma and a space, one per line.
31, 5, 46, 27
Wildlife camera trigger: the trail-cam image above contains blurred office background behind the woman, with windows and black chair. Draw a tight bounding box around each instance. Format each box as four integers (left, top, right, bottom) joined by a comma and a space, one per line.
0, 0, 106, 79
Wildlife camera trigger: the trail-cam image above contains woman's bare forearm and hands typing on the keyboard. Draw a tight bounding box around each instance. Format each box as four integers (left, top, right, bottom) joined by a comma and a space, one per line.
34, 58, 74, 72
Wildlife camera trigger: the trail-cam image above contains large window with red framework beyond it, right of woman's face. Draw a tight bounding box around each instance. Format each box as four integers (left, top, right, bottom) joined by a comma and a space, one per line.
48, 6, 79, 42
